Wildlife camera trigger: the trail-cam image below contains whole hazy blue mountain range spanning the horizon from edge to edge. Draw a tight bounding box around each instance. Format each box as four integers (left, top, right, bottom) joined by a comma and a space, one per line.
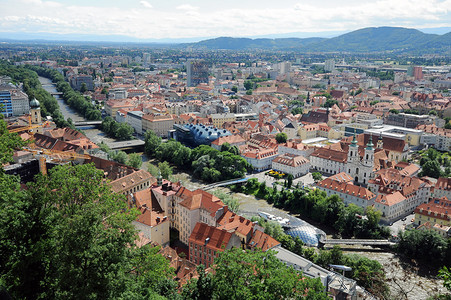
0, 27, 451, 55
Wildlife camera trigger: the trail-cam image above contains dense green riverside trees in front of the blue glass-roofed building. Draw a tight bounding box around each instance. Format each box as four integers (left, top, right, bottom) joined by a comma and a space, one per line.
145, 131, 250, 182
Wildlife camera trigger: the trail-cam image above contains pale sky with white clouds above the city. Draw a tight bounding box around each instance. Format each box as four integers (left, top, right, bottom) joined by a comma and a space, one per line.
0, 0, 451, 39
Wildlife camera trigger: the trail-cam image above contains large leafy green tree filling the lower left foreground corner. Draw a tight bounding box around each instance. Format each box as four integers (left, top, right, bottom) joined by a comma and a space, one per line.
0, 165, 174, 299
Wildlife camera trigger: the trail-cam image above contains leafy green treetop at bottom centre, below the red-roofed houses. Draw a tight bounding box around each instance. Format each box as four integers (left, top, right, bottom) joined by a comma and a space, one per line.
212, 248, 327, 299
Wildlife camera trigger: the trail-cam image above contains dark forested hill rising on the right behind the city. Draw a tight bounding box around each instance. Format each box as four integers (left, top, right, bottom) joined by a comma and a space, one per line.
182, 27, 451, 53
